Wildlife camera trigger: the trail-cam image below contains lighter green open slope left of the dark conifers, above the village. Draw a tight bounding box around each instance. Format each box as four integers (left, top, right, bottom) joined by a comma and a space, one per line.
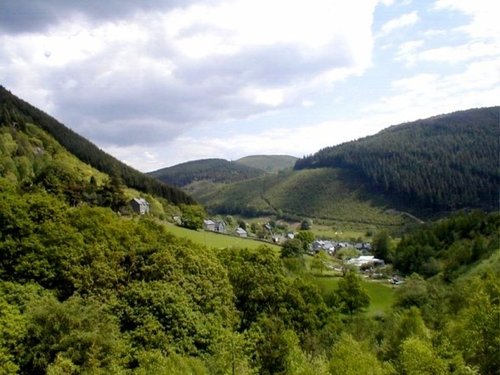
191, 168, 412, 226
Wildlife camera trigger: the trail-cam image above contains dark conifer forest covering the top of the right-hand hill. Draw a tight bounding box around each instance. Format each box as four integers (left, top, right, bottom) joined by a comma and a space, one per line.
295, 107, 500, 213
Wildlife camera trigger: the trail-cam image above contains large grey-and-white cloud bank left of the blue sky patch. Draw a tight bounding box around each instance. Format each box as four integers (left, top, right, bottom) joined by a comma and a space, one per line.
0, 0, 375, 151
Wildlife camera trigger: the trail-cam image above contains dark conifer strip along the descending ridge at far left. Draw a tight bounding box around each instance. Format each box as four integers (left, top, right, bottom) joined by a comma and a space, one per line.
0, 86, 194, 204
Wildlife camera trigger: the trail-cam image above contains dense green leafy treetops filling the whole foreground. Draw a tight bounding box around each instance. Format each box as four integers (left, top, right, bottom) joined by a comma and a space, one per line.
0, 181, 500, 374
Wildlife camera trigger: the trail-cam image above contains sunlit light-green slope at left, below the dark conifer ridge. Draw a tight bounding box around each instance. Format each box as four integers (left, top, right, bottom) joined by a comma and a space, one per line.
0, 119, 184, 218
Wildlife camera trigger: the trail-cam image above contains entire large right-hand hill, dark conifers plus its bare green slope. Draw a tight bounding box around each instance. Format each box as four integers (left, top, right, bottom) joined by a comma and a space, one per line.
188, 107, 500, 223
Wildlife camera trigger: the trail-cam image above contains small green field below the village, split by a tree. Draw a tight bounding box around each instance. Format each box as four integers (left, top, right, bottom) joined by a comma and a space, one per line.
313, 277, 395, 315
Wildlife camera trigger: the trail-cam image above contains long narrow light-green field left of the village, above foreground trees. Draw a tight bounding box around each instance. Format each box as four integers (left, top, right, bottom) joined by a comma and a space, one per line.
165, 225, 280, 251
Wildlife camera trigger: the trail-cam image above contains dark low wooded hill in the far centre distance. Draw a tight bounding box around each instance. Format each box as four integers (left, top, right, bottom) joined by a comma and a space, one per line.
149, 159, 265, 187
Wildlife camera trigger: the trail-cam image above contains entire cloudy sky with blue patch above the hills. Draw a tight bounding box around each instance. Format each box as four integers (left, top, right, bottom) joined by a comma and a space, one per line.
0, 0, 500, 172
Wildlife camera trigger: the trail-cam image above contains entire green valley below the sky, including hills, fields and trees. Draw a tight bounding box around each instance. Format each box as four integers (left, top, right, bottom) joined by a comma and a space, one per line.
0, 88, 500, 375
